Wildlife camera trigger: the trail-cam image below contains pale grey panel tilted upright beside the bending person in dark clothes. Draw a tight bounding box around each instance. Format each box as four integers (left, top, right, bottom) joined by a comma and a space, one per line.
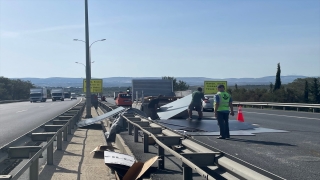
158, 94, 192, 120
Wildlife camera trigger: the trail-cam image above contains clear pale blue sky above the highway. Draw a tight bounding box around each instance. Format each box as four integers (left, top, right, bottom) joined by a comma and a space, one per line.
0, 0, 320, 78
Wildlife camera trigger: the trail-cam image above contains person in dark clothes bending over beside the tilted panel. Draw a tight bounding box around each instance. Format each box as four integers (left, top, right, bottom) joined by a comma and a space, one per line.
187, 87, 204, 120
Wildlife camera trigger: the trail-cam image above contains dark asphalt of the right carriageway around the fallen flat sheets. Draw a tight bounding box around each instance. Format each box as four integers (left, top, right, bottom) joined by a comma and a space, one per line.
196, 108, 320, 180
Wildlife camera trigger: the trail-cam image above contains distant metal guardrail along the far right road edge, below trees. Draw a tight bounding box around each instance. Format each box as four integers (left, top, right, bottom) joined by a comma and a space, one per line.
233, 101, 320, 113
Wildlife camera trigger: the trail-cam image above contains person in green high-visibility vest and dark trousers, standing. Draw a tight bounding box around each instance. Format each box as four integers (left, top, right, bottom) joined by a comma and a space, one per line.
214, 85, 234, 139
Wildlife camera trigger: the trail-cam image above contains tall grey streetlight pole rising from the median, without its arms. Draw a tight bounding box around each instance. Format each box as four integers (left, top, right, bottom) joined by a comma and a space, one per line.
84, 0, 92, 118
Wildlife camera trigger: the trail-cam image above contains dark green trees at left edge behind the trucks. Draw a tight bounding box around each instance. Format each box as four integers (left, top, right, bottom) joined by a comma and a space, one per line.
0, 76, 35, 101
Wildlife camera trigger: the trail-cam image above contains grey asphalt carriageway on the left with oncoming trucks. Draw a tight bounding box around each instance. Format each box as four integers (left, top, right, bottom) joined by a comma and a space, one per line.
0, 98, 81, 147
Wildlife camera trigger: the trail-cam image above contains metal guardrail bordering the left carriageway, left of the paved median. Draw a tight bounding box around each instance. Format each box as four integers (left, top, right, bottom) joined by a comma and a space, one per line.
0, 100, 85, 180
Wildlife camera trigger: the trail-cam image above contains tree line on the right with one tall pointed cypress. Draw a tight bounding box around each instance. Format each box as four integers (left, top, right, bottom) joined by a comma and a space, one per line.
228, 63, 320, 104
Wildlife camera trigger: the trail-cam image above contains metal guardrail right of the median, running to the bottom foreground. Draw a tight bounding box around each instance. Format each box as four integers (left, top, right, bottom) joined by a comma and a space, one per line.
101, 103, 283, 180
